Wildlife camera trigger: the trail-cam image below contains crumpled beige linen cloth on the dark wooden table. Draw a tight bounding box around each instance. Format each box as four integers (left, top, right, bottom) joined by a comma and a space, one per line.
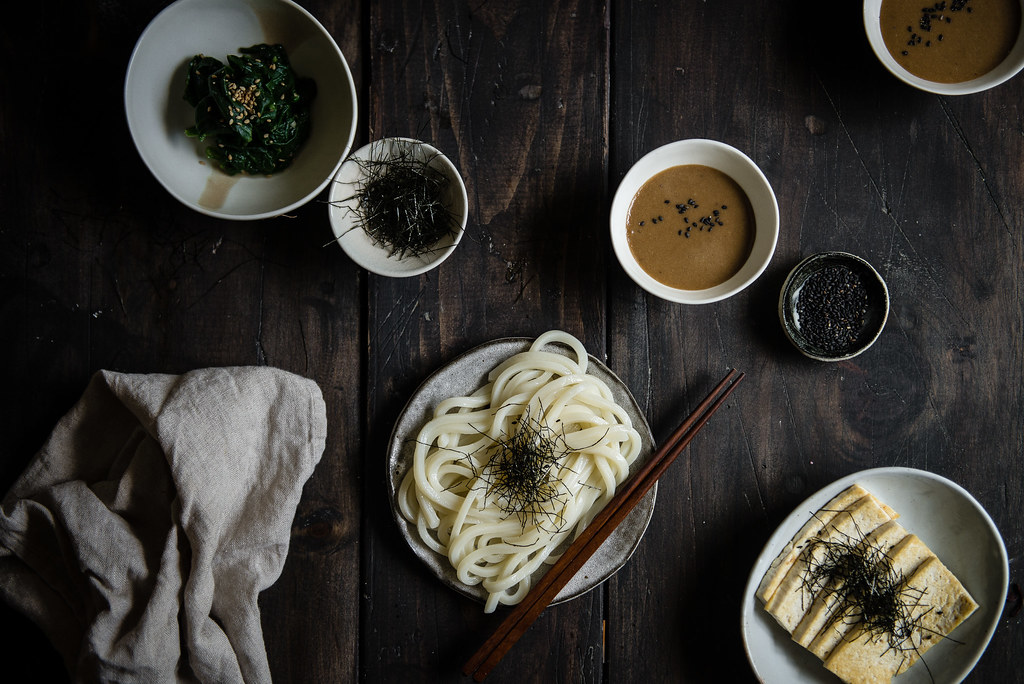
0, 368, 327, 683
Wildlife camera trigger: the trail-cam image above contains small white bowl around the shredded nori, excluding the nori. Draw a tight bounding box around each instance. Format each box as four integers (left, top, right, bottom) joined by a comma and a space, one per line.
328, 138, 469, 277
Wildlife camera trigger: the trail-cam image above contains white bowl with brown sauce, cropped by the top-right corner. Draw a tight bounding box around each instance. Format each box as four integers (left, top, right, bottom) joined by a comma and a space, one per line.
863, 0, 1024, 95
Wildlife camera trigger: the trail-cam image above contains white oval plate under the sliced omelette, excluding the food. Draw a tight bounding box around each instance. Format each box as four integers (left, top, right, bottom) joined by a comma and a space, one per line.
742, 468, 1010, 684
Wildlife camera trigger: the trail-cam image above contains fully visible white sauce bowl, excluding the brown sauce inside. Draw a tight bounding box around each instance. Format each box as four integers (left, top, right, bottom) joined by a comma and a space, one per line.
610, 138, 779, 304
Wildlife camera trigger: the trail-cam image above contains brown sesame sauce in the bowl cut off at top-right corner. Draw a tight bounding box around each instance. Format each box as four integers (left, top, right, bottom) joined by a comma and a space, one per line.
879, 0, 1021, 83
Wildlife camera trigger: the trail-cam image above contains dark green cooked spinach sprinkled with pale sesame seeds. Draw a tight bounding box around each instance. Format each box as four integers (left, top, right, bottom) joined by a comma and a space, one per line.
183, 43, 316, 175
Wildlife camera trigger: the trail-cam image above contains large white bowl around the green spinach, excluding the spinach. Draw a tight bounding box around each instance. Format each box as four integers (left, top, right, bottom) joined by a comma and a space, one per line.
125, 0, 356, 220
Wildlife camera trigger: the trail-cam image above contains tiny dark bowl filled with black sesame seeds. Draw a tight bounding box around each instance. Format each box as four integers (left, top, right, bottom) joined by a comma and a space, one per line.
778, 252, 889, 361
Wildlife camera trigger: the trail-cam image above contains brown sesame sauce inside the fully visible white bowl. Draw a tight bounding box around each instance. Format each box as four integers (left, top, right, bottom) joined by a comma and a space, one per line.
626, 164, 755, 290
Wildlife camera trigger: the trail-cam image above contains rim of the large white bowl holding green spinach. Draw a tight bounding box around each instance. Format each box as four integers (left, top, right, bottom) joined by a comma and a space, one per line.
122, 0, 358, 221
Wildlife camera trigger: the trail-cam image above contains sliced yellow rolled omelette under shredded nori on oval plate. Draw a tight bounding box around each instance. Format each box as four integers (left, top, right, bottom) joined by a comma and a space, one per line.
757, 484, 978, 684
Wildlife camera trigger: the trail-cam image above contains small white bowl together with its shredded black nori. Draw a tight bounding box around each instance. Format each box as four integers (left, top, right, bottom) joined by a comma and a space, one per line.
328, 137, 469, 277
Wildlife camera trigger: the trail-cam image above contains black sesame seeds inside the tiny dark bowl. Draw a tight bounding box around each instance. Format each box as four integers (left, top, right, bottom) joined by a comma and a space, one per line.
797, 265, 867, 354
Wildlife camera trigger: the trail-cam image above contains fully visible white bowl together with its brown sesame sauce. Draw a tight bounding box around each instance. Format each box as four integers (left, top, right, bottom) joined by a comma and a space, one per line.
609, 138, 779, 304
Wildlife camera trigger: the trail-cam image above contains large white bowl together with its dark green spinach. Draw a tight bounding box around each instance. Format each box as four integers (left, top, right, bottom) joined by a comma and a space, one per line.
125, 0, 356, 220
